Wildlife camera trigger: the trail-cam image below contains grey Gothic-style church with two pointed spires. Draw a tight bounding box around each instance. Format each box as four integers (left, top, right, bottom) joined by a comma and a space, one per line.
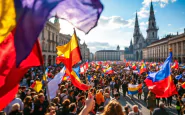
124, 2, 159, 61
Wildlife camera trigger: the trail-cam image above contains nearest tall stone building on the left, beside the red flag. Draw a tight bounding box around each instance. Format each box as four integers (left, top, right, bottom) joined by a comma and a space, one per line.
39, 19, 60, 66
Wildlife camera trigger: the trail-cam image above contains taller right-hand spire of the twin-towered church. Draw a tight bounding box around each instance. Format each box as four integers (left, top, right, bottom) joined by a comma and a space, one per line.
146, 2, 158, 45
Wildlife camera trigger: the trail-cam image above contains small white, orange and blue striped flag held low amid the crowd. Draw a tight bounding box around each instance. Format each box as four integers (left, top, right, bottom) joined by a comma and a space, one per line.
128, 84, 142, 95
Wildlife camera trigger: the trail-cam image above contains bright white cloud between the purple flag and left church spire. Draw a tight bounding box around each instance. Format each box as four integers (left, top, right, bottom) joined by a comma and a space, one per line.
50, 16, 135, 53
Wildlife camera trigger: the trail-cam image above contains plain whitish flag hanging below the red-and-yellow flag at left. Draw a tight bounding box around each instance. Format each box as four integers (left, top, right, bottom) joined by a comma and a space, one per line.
48, 67, 66, 99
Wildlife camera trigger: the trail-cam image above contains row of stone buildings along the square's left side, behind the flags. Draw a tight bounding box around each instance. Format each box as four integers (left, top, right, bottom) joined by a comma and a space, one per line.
39, 18, 90, 66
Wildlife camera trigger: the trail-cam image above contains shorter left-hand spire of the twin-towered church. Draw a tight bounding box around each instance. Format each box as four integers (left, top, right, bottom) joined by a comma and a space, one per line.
133, 12, 140, 45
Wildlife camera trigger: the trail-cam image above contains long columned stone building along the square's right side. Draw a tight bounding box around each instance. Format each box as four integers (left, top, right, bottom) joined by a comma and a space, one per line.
143, 30, 185, 63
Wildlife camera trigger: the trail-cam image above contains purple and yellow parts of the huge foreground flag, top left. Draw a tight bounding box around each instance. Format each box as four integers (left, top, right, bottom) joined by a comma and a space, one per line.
0, 0, 103, 66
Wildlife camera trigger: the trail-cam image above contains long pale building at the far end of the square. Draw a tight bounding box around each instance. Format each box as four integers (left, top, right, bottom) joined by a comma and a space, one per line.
95, 45, 124, 61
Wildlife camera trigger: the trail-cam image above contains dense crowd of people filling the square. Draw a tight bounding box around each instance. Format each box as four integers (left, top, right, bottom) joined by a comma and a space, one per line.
0, 63, 185, 115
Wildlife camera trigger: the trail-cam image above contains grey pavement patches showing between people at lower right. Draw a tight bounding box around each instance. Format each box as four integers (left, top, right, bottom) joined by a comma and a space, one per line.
116, 93, 177, 115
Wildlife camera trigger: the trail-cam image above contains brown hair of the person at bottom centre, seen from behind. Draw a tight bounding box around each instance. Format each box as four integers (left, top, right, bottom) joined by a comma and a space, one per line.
101, 100, 124, 115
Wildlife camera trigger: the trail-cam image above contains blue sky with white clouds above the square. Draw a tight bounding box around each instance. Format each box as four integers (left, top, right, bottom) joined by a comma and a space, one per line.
51, 0, 185, 53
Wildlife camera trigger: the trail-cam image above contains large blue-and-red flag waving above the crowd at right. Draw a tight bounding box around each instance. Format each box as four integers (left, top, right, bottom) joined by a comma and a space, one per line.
145, 52, 177, 97
